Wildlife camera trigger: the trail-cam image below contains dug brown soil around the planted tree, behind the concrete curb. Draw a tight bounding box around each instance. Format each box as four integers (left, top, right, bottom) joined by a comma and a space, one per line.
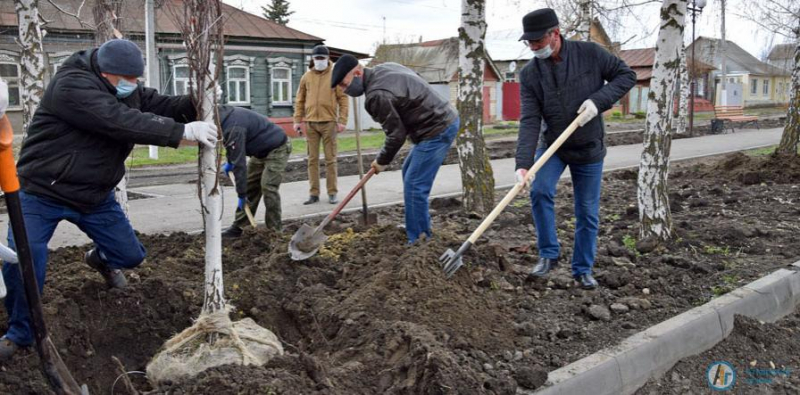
0, 150, 800, 395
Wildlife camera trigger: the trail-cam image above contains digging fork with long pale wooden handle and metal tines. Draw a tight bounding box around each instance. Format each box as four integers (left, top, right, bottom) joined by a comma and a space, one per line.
439, 117, 580, 278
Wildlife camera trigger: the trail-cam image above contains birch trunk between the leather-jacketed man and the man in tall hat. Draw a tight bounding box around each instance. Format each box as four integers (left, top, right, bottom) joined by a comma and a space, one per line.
456, 0, 494, 214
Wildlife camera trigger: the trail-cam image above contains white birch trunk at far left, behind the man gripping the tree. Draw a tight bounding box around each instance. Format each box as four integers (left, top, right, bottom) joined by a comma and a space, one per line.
14, 0, 45, 140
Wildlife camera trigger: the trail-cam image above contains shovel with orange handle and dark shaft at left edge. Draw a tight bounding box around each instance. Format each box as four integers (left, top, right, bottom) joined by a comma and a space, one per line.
0, 115, 89, 395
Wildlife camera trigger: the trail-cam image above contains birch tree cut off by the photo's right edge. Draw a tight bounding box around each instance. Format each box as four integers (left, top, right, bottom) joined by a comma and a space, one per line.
739, 0, 800, 155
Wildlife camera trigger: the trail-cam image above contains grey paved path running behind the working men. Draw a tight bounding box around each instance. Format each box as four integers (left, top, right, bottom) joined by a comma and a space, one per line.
0, 128, 783, 248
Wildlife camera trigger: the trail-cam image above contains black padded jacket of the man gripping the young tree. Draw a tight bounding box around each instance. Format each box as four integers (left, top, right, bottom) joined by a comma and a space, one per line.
17, 49, 195, 211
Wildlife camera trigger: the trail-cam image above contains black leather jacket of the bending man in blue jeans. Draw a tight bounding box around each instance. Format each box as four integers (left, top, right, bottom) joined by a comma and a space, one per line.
364, 63, 458, 165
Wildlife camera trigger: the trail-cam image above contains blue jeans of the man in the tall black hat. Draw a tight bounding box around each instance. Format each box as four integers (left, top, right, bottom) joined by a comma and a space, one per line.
531, 148, 603, 277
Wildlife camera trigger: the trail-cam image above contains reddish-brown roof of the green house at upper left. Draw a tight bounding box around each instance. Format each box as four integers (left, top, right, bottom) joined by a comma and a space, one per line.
0, 0, 323, 42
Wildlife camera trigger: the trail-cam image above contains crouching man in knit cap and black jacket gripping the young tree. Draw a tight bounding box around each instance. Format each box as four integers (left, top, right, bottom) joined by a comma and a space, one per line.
0, 40, 219, 360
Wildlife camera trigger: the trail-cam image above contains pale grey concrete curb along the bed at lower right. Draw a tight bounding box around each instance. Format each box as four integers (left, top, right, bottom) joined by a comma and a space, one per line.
517, 261, 800, 395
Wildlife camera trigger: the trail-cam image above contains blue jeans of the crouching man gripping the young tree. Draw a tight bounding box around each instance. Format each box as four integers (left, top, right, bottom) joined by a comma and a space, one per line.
3, 191, 145, 346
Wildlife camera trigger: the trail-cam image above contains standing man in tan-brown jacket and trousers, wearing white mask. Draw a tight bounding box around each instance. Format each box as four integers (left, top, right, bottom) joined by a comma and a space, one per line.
294, 45, 349, 204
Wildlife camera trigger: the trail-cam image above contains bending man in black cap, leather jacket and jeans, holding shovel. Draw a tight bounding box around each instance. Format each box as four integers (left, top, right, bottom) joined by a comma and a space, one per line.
331, 55, 459, 244
